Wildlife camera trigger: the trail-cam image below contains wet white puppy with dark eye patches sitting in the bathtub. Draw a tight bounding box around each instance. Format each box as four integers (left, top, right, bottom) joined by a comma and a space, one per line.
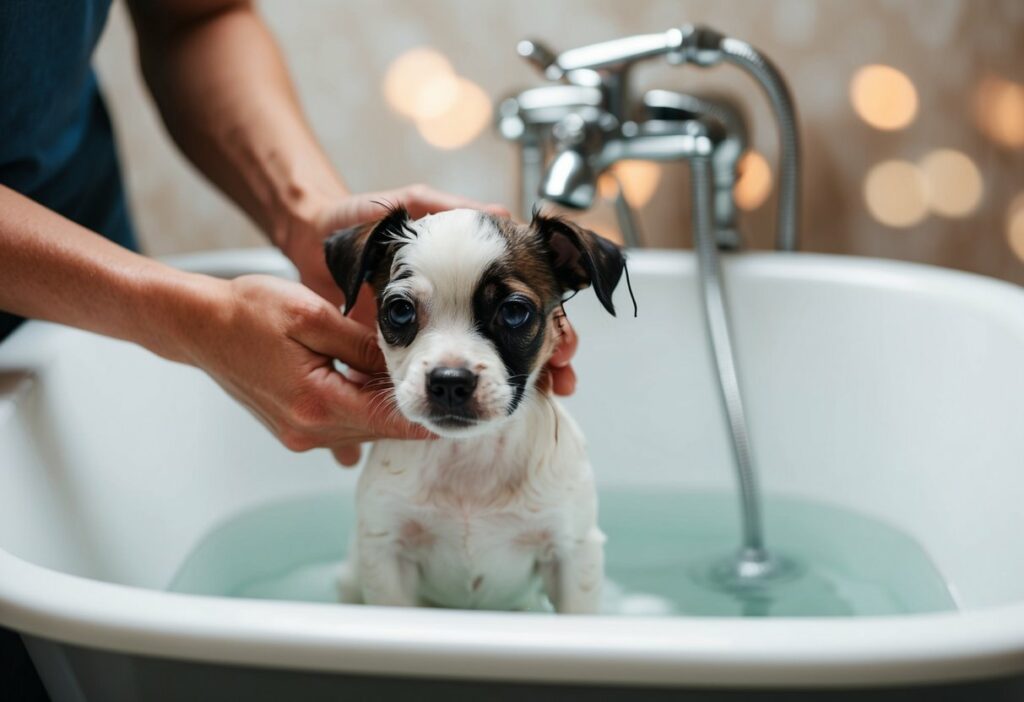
326, 208, 625, 613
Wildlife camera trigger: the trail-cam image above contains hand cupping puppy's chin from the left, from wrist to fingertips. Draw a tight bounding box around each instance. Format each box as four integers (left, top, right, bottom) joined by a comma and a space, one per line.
185, 275, 432, 466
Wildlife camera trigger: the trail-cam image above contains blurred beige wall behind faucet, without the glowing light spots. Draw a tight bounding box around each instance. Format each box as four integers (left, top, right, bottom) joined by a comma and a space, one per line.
97, 0, 1024, 283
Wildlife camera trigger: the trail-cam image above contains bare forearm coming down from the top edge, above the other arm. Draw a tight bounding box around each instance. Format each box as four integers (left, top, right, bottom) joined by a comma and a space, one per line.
126, 0, 347, 253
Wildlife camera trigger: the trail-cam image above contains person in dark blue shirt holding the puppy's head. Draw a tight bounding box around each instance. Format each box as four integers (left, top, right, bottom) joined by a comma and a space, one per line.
0, 0, 575, 696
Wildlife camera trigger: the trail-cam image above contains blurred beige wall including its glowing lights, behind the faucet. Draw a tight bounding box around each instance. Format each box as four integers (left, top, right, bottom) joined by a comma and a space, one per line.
97, 0, 1024, 284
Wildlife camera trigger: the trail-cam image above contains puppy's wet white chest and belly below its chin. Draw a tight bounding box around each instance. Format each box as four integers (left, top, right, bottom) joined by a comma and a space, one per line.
360, 445, 570, 609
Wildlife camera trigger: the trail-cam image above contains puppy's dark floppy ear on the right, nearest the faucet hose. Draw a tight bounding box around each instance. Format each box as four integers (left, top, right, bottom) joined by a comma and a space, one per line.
531, 213, 626, 316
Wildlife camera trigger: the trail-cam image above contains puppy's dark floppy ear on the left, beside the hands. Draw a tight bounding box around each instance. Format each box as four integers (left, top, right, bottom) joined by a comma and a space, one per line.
324, 207, 412, 314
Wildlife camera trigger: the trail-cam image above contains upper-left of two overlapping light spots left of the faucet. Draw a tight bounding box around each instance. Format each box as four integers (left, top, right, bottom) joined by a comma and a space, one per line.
384, 47, 459, 120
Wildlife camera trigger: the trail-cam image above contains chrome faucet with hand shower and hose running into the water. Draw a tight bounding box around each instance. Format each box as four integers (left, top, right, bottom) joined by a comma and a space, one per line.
499, 25, 800, 589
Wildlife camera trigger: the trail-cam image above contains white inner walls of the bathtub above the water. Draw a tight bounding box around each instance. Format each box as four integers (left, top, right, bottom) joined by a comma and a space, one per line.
0, 254, 1024, 609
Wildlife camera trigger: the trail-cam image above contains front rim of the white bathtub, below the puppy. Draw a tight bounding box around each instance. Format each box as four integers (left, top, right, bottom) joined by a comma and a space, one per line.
6, 551, 1024, 687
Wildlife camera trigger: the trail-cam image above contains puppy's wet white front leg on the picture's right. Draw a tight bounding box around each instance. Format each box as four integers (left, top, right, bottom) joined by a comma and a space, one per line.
543, 526, 604, 614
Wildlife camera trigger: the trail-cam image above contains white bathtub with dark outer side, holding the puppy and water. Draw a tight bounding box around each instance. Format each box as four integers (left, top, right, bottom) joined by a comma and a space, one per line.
0, 250, 1024, 701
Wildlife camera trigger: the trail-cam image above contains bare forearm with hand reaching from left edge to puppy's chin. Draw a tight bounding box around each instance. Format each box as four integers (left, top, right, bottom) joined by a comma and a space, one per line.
0, 185, 427, 465
